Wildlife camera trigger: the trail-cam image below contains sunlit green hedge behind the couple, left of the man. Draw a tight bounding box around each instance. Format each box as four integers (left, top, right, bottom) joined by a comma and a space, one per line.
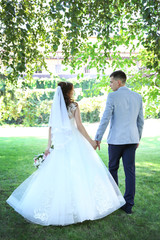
0, 78, 104, 126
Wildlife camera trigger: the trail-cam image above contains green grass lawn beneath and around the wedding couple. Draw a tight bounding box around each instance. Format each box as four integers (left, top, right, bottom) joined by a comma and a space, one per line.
0, 137, 160, 240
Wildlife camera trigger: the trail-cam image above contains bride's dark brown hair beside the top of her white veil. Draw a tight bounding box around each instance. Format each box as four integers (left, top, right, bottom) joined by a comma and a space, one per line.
58, 82, 74, 107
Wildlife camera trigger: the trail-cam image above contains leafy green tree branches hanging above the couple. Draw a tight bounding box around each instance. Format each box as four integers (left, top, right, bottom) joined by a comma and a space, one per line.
0, 0, 160, 116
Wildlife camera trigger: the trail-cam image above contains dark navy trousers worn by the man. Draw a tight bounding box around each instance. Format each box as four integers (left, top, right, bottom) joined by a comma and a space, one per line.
108, 144, 137, 206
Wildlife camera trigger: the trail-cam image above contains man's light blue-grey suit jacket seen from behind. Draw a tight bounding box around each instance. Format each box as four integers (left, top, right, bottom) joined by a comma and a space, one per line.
95, 87, 144, 145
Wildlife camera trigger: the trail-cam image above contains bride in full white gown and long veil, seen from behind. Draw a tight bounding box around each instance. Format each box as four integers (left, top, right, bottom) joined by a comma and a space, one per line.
7, 82, 125, 226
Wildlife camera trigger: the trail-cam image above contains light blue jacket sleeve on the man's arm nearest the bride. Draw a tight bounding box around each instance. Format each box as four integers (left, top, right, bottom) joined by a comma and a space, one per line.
95, 93, 113, 141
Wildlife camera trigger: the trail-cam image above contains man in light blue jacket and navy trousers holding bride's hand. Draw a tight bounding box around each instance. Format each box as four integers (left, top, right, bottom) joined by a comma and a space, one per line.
95, 71, 144, 214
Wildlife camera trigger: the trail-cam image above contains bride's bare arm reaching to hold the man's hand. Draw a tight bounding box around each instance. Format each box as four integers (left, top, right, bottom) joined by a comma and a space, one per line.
75, 106, 97, 149
